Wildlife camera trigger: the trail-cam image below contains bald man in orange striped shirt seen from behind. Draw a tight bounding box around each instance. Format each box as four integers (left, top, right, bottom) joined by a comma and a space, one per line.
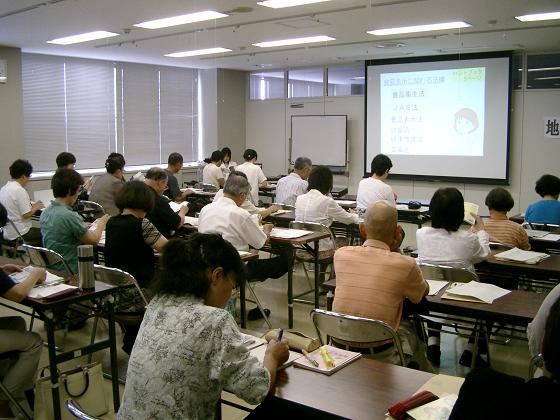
333, 201, 429, 361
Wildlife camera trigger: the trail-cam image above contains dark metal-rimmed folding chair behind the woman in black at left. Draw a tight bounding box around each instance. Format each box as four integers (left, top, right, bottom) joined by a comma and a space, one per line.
93, 264, 148, 312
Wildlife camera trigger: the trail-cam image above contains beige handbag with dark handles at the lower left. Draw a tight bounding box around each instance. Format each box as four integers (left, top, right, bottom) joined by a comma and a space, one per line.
35, 362, 109, 420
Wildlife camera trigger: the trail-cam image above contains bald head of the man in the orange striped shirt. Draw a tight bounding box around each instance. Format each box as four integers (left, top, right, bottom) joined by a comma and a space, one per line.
360, 200, 397, 247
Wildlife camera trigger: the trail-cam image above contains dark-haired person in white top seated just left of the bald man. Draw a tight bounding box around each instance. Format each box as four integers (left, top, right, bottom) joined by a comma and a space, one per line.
295, 166, 360, 250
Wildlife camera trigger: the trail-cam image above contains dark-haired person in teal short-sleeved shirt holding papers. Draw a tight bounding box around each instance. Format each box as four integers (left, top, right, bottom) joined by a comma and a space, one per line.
40, 169, 109, 273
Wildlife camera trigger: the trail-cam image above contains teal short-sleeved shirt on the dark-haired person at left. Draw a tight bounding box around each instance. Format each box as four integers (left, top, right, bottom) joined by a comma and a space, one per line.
41, 201, 88, 274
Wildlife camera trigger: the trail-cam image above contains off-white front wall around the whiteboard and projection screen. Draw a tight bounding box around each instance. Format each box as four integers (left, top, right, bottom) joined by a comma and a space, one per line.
246, 90, 560, 214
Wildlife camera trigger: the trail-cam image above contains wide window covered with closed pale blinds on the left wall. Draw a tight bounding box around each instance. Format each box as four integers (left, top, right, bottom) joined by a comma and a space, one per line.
22, 54, 198, 171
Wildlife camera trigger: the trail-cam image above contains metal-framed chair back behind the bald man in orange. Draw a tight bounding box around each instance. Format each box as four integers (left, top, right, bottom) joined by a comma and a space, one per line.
311, 309, 405, 366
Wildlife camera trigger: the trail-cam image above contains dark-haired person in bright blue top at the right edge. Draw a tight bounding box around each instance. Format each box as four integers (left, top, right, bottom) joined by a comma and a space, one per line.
525, 175, 560, 225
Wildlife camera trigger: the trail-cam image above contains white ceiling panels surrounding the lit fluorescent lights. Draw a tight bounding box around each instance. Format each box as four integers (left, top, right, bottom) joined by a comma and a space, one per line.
0, 0, 560, 70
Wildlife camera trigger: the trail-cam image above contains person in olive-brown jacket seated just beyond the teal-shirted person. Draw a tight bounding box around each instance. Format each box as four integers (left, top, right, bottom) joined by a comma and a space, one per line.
89, 153, 125, 216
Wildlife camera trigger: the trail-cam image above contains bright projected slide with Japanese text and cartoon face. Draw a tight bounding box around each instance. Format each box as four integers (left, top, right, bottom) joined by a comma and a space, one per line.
380, 67, 485, 156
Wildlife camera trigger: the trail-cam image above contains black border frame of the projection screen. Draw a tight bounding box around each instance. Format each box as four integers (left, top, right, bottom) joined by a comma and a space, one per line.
364, 51, 513, 185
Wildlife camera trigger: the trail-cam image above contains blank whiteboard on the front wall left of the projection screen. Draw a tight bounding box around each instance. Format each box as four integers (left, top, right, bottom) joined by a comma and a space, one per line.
290, 115, 347, 166
